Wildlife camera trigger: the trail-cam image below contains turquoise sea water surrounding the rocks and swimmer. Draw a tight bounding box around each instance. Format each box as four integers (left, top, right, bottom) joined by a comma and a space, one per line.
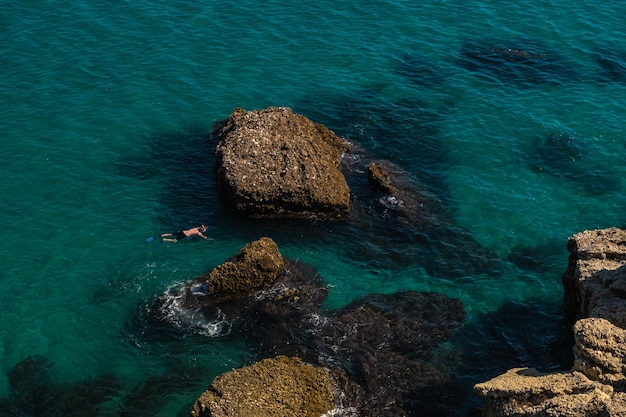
0, 0, 626, 416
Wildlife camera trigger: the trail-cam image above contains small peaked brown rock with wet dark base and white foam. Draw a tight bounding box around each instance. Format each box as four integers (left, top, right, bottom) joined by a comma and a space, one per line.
150, 237, 328, 336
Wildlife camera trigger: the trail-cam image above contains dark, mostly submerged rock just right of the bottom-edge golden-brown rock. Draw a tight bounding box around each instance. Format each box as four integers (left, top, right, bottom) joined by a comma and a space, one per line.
262, 291, 465, 417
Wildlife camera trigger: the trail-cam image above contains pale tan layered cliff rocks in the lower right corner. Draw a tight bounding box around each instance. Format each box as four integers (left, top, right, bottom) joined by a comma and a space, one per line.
474, 228, 626, 417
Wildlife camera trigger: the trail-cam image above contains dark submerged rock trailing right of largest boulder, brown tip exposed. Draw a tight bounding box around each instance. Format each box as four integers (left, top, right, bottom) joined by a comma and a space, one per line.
355, 161, 501, 278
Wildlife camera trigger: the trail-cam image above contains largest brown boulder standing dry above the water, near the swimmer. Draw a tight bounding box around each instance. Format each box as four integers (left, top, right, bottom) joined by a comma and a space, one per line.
212, 107, 350, 217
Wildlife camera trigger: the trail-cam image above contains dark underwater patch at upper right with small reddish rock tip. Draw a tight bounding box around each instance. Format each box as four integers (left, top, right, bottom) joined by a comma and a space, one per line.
459, 39, 580, 88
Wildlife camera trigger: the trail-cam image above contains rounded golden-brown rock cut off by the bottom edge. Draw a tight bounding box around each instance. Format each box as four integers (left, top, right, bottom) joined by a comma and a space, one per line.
191, 356, 340, 417
